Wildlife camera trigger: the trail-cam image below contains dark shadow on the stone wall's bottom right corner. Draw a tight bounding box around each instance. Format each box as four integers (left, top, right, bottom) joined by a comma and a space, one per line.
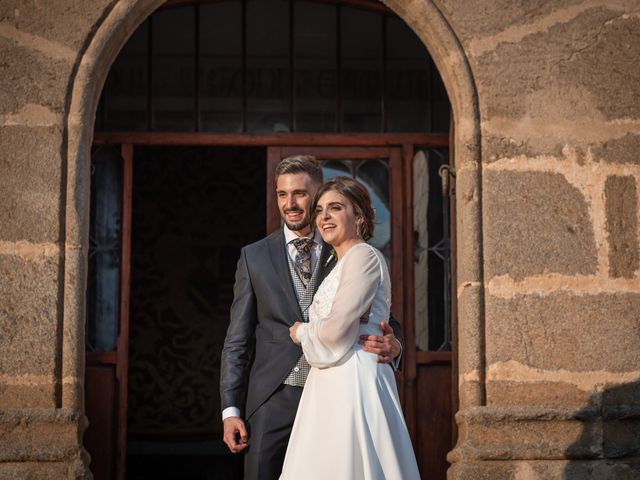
563, 382, 640, 480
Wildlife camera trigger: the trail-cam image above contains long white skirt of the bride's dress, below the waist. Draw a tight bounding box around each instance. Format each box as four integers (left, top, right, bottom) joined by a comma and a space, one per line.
280, 344, 420, 480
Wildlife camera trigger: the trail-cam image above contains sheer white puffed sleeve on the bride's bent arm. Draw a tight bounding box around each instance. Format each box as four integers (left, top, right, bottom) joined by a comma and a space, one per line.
296, 246, 381, 368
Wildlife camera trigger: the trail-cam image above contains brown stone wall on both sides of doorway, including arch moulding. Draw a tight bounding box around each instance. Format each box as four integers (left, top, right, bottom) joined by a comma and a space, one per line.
0, 0, 640, 480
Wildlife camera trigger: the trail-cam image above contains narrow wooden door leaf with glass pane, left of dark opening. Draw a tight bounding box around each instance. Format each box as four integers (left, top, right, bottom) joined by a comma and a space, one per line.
84, 144, 133, 480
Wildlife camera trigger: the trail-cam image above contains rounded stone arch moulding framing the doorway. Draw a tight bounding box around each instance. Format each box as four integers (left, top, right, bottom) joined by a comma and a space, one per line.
60, 0, 485, 468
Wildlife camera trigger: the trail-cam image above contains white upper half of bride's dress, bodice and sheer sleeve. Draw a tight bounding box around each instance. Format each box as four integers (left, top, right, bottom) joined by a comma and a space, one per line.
297, 243, 391, 368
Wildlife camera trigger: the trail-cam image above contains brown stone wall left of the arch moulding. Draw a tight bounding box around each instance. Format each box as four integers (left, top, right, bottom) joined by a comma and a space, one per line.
0, 0, 115, 479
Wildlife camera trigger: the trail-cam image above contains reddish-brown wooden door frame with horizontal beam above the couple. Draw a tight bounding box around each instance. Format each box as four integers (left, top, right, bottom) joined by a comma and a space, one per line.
93, 132, 457, 480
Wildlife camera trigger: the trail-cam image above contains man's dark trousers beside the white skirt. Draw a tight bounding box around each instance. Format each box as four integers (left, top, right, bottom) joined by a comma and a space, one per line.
244, 385, 302, 480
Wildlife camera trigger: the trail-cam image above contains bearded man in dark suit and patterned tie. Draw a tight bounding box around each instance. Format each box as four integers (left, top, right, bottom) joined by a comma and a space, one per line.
220, 155, 401, 480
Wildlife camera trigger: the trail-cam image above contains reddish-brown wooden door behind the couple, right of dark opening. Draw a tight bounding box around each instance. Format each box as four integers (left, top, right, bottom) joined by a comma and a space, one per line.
267, 144, 454, 480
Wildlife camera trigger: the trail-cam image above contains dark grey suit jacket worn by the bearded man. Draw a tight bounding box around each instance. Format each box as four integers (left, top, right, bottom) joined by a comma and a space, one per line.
220, 228, 400, 419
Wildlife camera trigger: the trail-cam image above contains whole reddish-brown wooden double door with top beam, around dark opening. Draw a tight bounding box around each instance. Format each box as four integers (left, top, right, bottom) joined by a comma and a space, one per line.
85, 133, 455, 480
